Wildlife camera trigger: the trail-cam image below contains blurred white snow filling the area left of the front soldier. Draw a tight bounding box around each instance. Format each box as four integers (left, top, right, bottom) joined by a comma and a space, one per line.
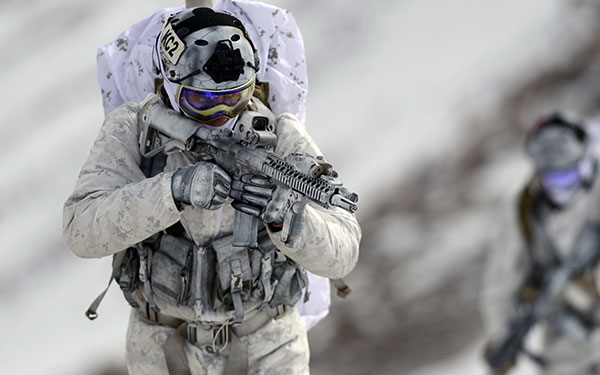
0, 0, 178, 374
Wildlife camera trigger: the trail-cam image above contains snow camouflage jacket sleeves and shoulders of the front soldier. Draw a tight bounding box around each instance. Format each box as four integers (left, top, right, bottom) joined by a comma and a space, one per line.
63, 94, 361, 318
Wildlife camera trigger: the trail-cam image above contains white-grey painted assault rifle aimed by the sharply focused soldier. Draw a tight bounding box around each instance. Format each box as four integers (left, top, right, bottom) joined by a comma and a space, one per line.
140, 100, 358, 247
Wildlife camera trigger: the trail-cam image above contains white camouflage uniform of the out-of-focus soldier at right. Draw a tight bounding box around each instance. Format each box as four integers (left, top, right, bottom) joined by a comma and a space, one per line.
481, 145, 600, 375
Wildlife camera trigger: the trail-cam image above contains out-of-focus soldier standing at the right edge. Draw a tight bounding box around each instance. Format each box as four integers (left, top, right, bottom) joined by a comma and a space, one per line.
482, 114, 600, 375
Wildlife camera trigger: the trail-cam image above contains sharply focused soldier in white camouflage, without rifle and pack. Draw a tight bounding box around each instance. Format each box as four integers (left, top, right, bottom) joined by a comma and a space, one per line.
64, 8, 360, 374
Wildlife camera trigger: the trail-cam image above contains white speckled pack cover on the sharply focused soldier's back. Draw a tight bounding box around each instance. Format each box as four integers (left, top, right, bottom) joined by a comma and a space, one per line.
97, 0, 331, 329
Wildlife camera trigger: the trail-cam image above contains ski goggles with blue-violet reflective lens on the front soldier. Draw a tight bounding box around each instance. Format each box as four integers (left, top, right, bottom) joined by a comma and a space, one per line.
177, 78, 255, 122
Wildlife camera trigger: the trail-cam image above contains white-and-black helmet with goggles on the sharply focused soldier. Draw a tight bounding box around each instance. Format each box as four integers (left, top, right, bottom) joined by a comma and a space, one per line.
155, 8, 259, 125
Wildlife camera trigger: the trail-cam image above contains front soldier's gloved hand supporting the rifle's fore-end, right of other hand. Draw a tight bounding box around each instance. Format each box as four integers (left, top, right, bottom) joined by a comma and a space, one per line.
230, 174, 306, 245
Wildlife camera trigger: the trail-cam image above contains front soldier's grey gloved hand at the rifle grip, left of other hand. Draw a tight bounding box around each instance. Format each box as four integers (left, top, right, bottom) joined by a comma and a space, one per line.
171, 162, 231, 210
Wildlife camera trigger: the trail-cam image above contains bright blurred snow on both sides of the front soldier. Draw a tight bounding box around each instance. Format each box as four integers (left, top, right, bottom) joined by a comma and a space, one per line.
0, 0, 562, 374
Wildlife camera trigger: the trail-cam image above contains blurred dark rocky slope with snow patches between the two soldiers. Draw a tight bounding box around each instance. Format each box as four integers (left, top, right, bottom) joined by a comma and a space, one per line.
300, 1, 600, 374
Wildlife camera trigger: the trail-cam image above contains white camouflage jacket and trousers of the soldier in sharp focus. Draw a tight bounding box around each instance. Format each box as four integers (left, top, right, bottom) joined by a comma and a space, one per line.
63, 94, 361, 374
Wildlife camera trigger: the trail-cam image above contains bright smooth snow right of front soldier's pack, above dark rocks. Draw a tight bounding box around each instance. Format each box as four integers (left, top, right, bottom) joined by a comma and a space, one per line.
301, 0, 558, 217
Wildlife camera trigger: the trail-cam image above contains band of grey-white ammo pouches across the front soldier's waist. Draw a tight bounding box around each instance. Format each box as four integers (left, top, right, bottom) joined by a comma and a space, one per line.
124, 230, 308, 324
